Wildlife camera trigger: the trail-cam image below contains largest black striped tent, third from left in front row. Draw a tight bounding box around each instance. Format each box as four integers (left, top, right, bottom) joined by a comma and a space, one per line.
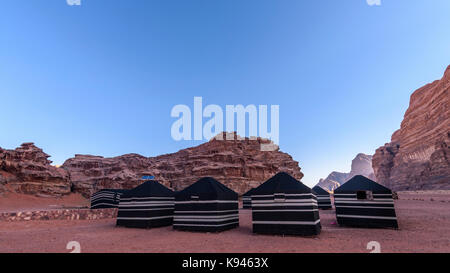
252, 172, 322, 236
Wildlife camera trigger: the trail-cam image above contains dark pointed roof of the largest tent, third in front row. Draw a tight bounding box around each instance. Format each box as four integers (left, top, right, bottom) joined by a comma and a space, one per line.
252, 172, 311, 195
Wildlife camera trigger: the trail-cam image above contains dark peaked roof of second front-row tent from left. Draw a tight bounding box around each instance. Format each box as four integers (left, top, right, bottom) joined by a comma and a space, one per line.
176, 177, 238, 200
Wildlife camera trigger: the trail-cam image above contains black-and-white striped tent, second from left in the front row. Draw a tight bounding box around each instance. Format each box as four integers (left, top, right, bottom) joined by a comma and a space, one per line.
173, 177, 239, 232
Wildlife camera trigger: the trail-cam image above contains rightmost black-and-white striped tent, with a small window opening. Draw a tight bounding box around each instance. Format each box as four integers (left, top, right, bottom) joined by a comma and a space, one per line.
334, 175, 398, 228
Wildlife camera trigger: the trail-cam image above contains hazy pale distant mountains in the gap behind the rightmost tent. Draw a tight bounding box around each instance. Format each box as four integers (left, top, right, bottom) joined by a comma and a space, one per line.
317, 153, 375, 192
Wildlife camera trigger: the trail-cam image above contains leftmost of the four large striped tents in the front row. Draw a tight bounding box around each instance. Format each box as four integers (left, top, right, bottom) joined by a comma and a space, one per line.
117, 181, 175, 228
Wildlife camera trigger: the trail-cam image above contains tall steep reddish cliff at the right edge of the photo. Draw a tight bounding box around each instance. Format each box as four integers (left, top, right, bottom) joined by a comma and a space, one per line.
372, 66, 450, 191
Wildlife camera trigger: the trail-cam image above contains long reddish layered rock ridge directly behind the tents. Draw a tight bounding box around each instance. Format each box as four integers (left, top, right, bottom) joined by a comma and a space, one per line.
62, 131, 303, 196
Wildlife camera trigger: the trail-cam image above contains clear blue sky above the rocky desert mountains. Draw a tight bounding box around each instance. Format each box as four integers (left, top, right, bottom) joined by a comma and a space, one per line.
0, 0, 450, 186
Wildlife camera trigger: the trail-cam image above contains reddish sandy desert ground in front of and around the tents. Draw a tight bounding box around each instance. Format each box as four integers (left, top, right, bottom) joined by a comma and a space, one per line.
0, 191, 450, 253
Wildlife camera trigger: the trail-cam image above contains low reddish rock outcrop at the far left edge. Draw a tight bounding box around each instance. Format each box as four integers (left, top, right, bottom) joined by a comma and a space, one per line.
0, 143, 71, 196
